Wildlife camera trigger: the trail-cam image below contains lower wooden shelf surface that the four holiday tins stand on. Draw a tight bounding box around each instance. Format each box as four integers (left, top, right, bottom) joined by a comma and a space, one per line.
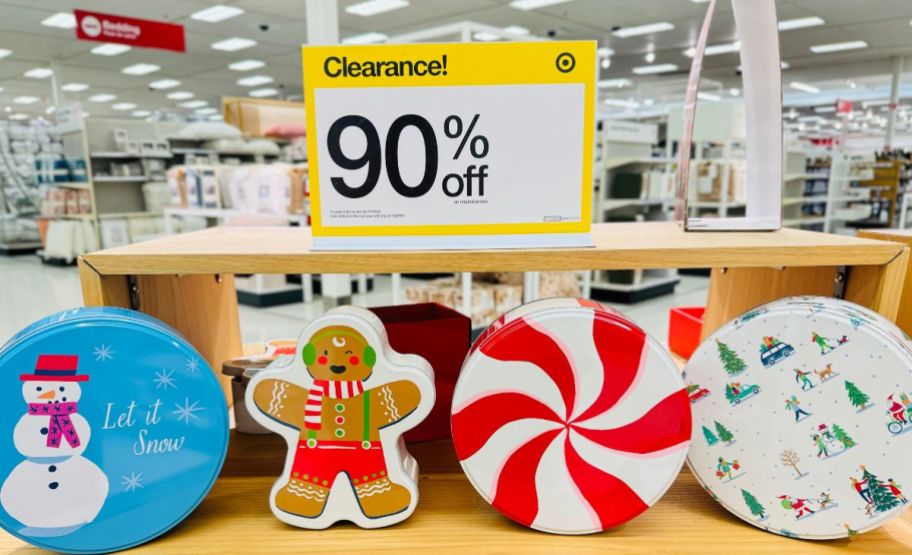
0, 434, 912, 555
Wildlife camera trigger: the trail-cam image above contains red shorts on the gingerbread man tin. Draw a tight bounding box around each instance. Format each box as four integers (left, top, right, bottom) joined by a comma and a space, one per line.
291, 439, 386, 487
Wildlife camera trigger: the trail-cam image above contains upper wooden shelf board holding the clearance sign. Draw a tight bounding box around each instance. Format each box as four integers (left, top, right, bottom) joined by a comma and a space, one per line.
84, 222, 902, 275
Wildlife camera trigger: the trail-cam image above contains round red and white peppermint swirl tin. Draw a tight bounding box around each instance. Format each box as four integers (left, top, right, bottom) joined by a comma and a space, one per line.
452, 299, 691, 534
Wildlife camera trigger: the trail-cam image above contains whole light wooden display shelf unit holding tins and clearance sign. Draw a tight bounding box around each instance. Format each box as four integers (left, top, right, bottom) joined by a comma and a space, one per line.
58, 222, 912, 553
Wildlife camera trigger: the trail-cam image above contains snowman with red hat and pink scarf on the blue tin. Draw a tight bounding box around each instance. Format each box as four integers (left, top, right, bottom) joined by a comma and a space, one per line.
0, 355, 108, 537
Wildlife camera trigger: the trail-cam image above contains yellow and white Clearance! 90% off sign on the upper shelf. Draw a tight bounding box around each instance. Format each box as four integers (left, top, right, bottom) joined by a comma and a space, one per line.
303, 42, 596, 249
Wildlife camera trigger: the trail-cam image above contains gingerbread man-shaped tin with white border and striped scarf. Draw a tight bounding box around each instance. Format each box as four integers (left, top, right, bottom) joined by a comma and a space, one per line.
246, 307, 434, 529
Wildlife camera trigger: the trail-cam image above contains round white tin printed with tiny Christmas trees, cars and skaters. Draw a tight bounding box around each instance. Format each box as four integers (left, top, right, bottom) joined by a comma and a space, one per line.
686, 297, 912, 539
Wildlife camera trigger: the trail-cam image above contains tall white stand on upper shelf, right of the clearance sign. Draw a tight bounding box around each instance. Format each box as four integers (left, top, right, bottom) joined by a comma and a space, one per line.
675, 0, 783, 231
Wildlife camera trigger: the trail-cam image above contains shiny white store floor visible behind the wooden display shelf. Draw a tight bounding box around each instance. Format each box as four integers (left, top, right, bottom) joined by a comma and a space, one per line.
0, 256, 708, 344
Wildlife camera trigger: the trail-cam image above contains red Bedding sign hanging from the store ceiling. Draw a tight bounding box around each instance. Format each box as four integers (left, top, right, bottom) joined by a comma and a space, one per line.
73, 10, 187, 52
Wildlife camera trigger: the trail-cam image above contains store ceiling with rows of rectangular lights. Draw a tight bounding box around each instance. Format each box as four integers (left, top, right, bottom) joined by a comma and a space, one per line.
0, 0, 912, 120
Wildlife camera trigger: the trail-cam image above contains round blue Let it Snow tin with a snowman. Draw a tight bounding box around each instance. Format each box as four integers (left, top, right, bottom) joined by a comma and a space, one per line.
0, 308, 229, 553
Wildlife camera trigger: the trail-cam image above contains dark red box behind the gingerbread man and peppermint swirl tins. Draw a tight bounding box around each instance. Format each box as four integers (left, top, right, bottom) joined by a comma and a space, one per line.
370, 303, 472, 443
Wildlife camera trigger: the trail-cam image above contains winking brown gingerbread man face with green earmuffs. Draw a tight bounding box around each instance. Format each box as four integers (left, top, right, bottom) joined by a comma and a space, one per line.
301, 326, 377, 381
